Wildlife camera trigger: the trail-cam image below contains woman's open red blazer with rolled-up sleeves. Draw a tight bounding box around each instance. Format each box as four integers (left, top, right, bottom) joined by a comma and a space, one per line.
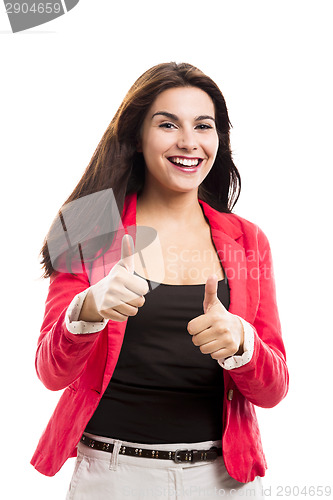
31, 194, 288, 483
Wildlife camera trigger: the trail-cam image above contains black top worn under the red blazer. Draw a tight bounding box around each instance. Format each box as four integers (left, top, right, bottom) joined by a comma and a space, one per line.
86, 272, 229, 444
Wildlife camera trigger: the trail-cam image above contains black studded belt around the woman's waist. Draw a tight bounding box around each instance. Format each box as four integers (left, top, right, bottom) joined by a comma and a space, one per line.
80, 434, 222, 464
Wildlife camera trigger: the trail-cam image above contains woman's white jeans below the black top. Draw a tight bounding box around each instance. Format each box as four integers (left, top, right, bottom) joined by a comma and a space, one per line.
66, 433, 264, 500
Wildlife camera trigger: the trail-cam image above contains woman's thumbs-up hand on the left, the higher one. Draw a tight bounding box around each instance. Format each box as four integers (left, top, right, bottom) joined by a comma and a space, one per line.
79, 234, 148, 322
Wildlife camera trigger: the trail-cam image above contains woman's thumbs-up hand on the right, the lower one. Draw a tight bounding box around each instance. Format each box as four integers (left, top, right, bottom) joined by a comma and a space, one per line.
187, 274, 244, 359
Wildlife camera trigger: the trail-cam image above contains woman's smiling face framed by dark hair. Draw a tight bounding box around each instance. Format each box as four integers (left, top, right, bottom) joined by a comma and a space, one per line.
139, 87, 219, 197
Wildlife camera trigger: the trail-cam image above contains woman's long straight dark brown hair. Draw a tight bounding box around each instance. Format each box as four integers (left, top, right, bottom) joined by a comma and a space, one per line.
41, 62, 241, 278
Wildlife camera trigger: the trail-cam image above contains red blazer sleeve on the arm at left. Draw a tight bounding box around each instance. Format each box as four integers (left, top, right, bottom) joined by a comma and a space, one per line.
35, 272, 103, 391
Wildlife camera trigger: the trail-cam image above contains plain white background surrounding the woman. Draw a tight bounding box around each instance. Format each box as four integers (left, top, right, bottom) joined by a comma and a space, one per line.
0, 0, 333, 500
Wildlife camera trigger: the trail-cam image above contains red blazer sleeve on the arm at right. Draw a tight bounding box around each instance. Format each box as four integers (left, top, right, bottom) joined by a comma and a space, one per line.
229, 228, 289, 408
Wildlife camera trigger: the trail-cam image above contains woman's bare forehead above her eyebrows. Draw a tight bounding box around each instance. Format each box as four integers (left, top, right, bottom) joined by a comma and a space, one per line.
148, 87, 215, 117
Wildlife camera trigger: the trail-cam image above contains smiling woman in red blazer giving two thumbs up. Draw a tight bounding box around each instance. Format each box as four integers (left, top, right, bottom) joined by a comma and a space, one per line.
32, 63, 288, 499
